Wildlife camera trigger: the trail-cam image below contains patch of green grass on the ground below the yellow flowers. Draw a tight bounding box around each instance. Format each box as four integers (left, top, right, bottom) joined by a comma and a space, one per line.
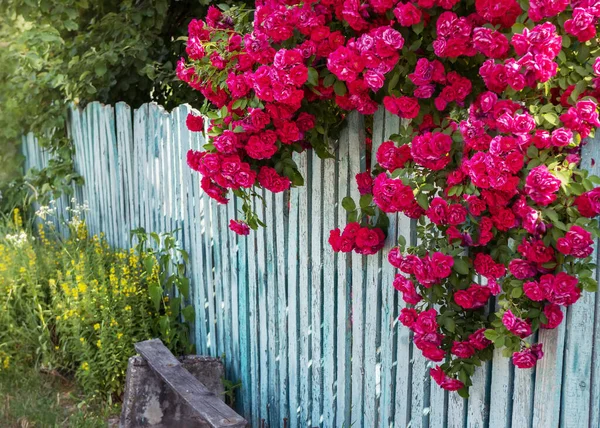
0, 369, 119, 428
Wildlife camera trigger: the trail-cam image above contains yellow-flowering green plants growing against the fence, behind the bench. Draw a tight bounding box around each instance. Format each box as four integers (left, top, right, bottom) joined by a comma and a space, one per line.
0, 209, 193, 398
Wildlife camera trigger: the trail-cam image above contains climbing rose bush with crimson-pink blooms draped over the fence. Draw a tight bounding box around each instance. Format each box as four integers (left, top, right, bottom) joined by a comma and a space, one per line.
177, 0, 600, 396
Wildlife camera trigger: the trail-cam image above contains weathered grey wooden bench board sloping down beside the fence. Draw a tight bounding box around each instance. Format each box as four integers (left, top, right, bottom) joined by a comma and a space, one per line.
135, 339, 247, 428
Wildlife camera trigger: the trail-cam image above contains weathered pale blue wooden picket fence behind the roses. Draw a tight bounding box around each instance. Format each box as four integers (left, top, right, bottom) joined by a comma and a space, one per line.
23, 103, 600, 428
